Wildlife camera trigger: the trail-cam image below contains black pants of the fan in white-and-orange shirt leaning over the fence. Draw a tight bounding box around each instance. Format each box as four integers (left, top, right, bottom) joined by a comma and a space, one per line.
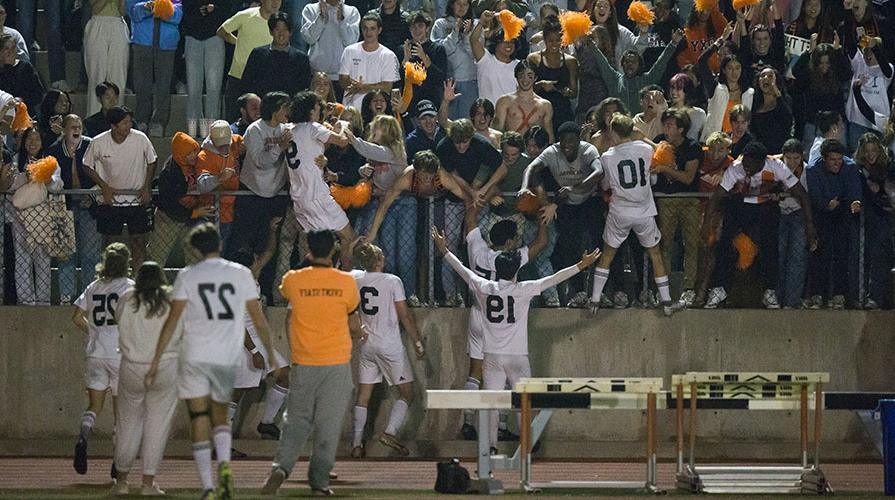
712, 201, 780, 290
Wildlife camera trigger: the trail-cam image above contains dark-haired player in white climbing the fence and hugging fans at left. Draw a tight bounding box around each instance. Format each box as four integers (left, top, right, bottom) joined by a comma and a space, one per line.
286, 90, 356, 264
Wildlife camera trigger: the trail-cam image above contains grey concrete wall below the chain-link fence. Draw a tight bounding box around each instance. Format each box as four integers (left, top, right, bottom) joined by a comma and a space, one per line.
0, 307, 895, 459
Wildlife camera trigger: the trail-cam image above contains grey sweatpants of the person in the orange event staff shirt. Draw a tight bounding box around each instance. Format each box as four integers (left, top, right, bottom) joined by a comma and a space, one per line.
273, 364, 354, 489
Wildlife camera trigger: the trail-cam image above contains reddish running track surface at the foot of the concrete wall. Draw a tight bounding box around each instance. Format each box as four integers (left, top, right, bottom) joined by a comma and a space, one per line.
0, 458, 883, 493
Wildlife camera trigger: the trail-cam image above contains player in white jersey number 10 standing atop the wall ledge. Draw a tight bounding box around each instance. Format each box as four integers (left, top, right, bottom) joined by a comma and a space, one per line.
572, 113, 681, 316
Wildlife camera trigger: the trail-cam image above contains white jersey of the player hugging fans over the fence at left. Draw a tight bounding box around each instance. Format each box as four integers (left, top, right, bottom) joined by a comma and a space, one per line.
286, 122, 332, 204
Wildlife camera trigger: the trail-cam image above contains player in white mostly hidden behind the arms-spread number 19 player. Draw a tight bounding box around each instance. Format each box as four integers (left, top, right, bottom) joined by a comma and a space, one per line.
460, 197, 547, 441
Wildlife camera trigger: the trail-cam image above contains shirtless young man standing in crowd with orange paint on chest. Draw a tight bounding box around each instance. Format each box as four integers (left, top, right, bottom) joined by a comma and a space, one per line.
494, 60, 554, 142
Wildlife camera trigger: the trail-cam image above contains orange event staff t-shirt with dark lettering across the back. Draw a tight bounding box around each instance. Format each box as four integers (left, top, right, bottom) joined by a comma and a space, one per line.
280, 266, 360, 366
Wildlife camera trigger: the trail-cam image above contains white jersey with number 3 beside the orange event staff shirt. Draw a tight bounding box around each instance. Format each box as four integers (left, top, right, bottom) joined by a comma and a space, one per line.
351, 270, 406, 347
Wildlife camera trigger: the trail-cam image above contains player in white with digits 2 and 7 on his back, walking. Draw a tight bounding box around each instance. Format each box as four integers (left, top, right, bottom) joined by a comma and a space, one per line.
146, 224, 273, 499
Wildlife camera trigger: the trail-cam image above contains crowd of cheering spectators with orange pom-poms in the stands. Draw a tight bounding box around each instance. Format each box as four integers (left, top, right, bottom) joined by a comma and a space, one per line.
0, 0, 895, 309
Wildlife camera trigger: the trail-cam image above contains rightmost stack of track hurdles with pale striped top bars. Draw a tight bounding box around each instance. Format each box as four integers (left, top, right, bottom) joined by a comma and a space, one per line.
671, 372, 832, 494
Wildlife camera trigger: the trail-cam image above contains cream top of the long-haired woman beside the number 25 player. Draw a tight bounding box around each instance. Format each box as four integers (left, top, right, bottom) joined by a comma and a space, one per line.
115, 288, 183, 364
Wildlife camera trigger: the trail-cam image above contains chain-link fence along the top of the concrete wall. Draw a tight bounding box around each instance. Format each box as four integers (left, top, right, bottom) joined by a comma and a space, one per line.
0, 190, 895, 308
